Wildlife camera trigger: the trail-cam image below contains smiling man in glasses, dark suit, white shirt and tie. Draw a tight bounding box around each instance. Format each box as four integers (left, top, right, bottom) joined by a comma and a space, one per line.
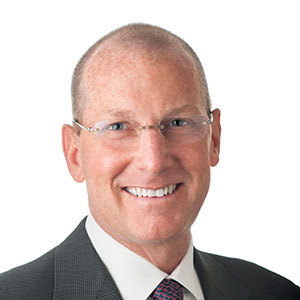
0, 24, 300, 300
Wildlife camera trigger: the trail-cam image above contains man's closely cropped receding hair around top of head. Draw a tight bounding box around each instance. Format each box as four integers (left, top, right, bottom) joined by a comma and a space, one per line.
72, 23, 211, 119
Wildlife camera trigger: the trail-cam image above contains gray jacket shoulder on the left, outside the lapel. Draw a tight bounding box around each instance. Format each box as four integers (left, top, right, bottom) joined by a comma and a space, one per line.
0, 250, 55, 300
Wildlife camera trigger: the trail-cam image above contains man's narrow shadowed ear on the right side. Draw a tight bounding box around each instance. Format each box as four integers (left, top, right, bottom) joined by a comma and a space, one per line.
210, 109, 221, 167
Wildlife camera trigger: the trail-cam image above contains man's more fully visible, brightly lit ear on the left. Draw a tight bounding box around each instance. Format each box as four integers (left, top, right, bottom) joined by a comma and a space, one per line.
62, 124, 84, 182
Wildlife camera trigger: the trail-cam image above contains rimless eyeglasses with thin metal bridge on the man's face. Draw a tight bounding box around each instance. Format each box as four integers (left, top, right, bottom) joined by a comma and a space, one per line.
73, 114, 212, 146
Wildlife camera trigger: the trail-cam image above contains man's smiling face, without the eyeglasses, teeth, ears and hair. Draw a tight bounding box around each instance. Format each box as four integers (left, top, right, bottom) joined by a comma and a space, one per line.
68, 44, 217, 244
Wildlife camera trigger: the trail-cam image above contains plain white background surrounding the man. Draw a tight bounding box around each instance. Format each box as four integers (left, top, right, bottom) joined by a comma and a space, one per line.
0, 0, 300, 285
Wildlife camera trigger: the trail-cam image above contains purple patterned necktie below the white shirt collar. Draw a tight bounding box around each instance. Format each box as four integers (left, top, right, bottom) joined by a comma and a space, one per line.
151, 279, 183, 300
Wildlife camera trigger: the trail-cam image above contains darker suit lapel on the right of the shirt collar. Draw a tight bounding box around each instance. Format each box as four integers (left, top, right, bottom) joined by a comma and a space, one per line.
194, 249, 250, 300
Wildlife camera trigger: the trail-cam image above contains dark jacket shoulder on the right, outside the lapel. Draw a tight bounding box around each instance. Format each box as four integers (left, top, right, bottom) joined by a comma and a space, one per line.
197, 251, 300, 300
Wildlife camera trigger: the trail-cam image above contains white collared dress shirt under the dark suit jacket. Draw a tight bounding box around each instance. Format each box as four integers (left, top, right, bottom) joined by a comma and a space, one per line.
85, 215, 204, 300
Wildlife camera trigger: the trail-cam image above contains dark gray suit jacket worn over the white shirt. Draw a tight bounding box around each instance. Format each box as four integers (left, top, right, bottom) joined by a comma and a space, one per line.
0, 219, 300, 300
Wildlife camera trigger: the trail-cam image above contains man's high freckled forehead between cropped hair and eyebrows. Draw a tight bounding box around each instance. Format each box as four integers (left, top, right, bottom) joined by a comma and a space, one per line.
83, 41, 204, 118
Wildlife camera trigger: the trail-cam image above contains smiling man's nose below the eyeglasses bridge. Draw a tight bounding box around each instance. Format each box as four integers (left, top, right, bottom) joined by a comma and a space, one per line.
136, 128, 169, 174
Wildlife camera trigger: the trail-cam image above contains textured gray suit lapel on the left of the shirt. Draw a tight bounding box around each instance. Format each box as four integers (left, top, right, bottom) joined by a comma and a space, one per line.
53, 218, 122, 300
